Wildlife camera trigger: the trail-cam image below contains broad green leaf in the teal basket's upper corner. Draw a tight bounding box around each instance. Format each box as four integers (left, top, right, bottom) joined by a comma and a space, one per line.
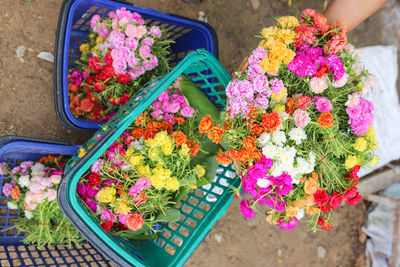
181, 75, 221, 123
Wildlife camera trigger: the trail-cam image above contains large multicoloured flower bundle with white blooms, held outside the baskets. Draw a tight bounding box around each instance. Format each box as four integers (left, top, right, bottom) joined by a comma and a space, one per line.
199, 9, 378, 231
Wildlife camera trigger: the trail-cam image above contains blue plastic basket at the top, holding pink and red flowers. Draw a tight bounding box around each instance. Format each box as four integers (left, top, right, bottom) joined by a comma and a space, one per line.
54, 0, 218, 130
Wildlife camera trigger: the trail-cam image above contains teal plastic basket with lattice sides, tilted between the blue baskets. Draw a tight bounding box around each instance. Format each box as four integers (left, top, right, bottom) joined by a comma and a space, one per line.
58, 50, 240, 266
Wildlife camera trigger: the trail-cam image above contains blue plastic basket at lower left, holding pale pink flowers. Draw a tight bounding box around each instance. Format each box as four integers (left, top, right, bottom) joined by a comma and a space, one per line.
0, 136, 113, 266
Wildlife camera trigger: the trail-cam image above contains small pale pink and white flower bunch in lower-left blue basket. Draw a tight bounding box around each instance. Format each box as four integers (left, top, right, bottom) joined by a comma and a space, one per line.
0, 155, 83, 248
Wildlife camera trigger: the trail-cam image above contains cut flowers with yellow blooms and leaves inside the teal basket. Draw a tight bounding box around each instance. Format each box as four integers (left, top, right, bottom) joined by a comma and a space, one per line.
77, 76, 219, 239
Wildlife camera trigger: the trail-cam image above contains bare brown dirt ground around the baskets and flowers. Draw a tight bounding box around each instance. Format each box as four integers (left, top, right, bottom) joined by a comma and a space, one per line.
0, 0, 399, 266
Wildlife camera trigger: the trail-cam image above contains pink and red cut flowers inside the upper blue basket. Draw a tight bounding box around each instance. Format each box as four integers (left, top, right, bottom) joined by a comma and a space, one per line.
68, 8, 172, 121
